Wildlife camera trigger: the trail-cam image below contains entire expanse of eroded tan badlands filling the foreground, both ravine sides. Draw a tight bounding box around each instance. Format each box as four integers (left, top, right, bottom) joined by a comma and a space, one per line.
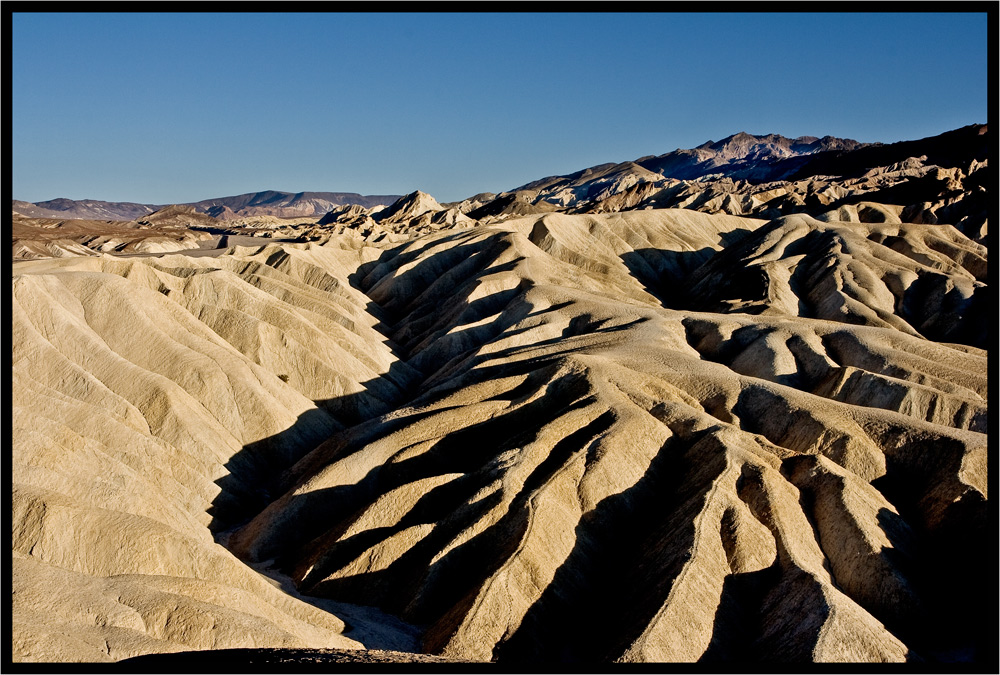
12, 205, 992, 664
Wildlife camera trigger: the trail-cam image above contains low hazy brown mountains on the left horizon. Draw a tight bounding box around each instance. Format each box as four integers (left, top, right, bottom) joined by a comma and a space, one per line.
13, 190, 401, 221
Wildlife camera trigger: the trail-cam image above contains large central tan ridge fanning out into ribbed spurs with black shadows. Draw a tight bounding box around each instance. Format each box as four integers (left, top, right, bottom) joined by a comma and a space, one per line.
230, 213, 986, 661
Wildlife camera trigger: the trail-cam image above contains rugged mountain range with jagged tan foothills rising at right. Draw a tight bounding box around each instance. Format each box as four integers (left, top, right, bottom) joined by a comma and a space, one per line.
480, 124, 991, 245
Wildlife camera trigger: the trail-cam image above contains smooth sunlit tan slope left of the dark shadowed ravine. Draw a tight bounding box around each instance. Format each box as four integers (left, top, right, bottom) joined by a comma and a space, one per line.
12, 242, 414, 661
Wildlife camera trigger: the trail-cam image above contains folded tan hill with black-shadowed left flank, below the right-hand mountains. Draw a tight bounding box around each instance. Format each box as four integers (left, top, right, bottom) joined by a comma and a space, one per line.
687, 215, 988, 348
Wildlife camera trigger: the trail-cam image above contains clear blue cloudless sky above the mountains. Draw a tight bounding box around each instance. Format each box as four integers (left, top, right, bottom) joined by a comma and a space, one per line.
8, 10, 988, 204
